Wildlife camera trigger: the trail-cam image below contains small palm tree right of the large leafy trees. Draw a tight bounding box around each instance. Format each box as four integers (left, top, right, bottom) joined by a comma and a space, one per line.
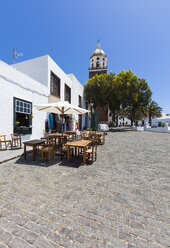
148, 101, 162, 126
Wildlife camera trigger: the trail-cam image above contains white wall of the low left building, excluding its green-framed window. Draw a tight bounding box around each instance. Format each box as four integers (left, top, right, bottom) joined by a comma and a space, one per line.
0, 61, 48, 140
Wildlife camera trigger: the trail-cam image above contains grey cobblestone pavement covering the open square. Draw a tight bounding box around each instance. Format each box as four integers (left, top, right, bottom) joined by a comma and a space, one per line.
0, 131, 170, 248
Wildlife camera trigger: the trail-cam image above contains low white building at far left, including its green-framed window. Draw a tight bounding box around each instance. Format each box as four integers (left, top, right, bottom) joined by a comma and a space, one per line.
0, 61, 48, 140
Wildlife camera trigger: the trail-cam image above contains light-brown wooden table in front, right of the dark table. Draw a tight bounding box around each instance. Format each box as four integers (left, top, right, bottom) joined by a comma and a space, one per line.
66, 140, 91, 164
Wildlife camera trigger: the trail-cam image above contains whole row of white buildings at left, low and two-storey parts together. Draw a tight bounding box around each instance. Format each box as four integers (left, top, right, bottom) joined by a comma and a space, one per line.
0, 55, 89, 140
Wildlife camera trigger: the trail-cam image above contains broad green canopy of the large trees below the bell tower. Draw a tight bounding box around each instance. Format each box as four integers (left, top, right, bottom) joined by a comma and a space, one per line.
84, 70, 160, 124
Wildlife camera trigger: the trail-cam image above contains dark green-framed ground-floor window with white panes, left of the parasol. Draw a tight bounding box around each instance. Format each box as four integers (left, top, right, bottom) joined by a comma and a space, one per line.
14, 97, 32, 134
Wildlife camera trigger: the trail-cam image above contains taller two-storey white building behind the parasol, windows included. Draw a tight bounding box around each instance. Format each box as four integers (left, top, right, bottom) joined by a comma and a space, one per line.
12, 55, 88, 130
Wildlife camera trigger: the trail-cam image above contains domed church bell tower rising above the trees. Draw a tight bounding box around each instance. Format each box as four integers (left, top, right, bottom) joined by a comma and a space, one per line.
89, 42, 107, 78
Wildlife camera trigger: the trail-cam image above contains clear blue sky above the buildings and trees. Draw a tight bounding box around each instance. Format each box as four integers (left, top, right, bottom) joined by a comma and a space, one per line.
0, 0, 170, 113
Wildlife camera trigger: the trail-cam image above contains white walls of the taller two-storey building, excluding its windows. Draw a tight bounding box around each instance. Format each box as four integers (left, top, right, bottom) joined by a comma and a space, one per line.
12, 55, 88, 129
